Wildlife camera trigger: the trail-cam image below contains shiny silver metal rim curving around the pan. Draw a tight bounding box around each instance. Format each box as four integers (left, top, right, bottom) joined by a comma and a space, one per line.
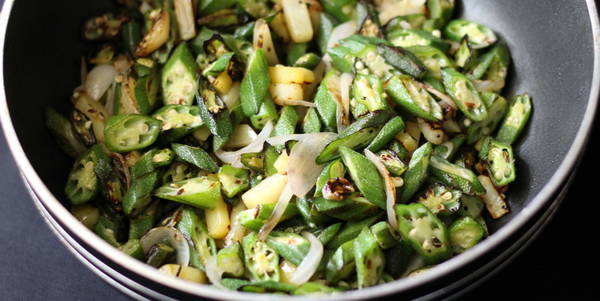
0, 0, 600, 300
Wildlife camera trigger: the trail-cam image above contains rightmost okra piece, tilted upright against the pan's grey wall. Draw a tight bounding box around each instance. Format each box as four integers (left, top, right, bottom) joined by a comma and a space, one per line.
496, 94, 532, 145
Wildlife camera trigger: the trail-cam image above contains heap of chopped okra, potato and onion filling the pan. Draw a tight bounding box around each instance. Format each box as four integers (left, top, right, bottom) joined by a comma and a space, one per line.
46, 0, 532, 294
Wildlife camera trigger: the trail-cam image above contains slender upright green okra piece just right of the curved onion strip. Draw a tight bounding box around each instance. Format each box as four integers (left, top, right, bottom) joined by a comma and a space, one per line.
400, 142, 433, 203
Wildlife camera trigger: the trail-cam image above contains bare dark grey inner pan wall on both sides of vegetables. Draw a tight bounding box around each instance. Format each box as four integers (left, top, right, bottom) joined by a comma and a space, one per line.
3, 0, 594, 268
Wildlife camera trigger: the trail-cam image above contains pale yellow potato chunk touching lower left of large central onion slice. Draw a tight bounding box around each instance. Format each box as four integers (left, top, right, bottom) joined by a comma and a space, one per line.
242, 174, 287, 209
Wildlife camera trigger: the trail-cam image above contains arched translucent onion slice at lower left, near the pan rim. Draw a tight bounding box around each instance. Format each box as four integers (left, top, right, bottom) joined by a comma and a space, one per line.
140, 227, 190, 266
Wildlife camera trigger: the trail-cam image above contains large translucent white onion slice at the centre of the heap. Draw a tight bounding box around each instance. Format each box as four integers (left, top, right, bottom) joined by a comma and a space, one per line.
288, 133, 337, 197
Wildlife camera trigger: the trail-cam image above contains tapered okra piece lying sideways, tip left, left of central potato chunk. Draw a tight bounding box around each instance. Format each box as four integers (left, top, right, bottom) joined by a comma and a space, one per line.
154, 177, 222, 209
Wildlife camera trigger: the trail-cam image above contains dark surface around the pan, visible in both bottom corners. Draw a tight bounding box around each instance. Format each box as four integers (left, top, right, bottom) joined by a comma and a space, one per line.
0, 0, 600, 300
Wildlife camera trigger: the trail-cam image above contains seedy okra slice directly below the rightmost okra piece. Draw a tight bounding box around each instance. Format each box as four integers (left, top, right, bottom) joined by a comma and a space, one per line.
480, 139, 516, 187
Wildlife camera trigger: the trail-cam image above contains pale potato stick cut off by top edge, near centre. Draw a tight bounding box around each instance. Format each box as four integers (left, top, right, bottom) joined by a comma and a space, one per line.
281, 0, 314, 43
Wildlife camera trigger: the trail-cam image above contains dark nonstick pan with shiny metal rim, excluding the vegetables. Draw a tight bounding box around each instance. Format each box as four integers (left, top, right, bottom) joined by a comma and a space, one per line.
0, 0, 600, 300
